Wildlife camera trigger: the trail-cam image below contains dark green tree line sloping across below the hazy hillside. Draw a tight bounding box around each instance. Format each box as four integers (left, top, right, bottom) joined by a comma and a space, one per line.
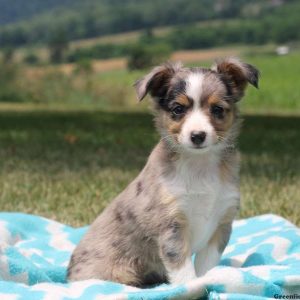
65, 3, 300, 68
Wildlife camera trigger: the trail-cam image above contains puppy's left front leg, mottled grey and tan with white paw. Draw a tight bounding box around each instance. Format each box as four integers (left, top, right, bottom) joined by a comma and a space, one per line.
159, 219, 196, 284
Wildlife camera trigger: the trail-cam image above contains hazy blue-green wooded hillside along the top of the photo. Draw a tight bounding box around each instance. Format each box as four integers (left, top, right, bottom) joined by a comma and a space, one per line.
0, 0, 288, 47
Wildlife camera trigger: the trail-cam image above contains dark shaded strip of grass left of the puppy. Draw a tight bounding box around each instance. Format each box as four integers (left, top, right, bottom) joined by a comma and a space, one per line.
0, 111, 157, 172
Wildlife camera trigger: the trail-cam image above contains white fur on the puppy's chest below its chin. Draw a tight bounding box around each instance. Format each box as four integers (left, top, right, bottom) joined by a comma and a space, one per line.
167, 153, 239, 253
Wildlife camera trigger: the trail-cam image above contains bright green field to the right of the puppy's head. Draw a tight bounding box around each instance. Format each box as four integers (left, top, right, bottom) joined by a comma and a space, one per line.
242, 52, 300, 113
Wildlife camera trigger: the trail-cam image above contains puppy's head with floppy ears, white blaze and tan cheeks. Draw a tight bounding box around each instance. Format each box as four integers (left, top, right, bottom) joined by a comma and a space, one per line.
135, 58, 259, 153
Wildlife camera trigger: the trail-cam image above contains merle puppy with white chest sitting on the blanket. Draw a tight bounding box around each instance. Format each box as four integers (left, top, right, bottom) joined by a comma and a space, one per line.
68, 58, 259, 287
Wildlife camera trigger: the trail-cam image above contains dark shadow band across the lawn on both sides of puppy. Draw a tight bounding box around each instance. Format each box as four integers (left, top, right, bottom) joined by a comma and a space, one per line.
0, 111, 300, 176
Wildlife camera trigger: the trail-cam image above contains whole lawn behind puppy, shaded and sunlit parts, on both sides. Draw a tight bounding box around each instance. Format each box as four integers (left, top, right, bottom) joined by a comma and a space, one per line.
0, 110, 300, 225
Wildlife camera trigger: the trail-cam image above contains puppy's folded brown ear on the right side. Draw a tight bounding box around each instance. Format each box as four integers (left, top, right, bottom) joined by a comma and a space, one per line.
212, 58, 260, 101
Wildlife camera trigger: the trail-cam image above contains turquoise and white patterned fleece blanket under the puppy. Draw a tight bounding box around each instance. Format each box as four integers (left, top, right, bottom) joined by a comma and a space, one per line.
0, 213, 300, 300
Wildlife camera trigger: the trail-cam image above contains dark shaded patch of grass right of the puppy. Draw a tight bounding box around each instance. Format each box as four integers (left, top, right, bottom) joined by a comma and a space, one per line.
239, 115, 300, 180
